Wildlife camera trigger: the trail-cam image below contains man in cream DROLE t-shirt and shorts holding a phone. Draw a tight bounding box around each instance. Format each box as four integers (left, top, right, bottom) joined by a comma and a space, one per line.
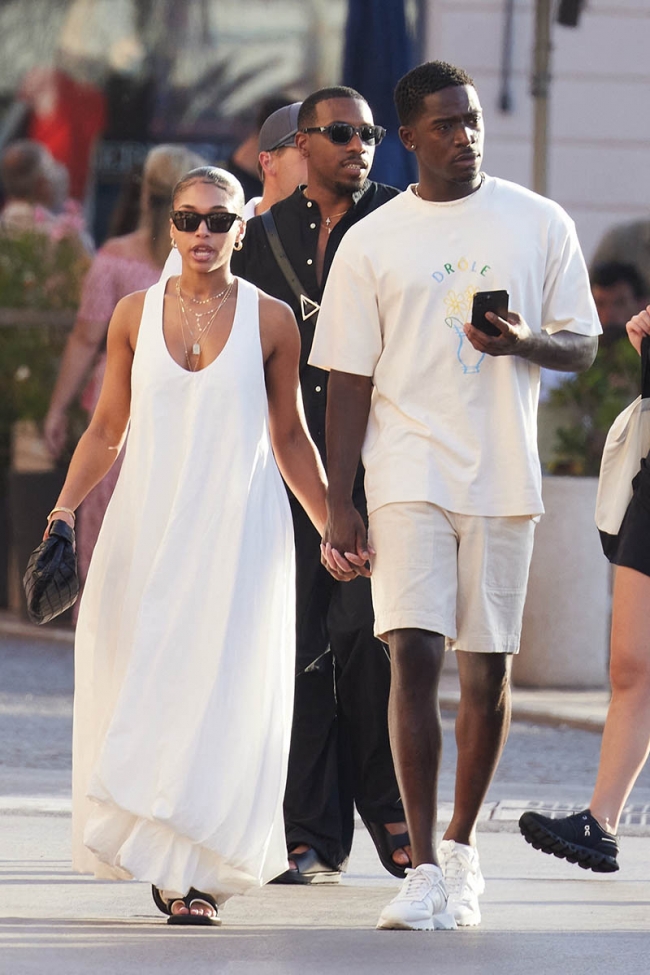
310, 62, 600, 930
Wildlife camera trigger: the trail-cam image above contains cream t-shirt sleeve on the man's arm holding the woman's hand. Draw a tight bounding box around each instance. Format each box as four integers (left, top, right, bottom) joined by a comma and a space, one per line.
309, 234, 383, 376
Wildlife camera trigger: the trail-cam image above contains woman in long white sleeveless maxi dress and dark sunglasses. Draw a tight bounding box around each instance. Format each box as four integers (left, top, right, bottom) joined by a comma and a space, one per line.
44, 168, 334, 923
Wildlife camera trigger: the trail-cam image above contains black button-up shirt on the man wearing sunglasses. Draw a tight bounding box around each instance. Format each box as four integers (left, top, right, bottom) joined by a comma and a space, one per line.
231, 180, 400, 459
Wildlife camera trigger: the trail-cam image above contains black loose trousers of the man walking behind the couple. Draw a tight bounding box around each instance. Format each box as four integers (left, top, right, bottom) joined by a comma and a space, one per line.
284, 499, 404, 868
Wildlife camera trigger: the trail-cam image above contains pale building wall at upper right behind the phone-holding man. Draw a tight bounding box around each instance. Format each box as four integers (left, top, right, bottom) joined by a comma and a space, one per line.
425, 0, 650, 260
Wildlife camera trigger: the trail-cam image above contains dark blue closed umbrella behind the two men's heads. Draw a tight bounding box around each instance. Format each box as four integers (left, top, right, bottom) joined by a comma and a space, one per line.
343, 0, 416, 189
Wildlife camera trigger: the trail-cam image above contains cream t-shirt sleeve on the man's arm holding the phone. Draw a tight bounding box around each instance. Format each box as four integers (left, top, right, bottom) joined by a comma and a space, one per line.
542, 211, 602, 335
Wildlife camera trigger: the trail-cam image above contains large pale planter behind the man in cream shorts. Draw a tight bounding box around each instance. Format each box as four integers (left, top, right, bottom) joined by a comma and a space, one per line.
513, 477, 611, 688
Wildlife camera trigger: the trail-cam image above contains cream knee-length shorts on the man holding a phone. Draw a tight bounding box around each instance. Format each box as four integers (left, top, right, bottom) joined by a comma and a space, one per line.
369, 501, 537, 653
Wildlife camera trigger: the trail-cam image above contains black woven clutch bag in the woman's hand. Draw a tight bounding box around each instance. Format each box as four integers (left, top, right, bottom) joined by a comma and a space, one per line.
23, 520, 79, 623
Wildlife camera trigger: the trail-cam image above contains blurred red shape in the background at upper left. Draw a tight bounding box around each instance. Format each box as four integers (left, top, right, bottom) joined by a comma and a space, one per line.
20, 68, 106, 200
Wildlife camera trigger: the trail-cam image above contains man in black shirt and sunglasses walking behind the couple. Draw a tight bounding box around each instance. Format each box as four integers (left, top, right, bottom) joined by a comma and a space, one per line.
231, 87, 410, 883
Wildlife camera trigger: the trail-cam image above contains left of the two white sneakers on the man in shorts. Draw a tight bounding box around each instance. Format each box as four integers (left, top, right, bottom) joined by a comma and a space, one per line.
377, 863, 456, 931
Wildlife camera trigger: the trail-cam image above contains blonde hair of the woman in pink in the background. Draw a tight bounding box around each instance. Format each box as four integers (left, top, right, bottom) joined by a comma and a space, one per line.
140, 145, 205, 267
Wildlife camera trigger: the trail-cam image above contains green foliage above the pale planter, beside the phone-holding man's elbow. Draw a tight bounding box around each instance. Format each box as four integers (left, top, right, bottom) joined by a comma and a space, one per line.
549, 337, 641, 477
